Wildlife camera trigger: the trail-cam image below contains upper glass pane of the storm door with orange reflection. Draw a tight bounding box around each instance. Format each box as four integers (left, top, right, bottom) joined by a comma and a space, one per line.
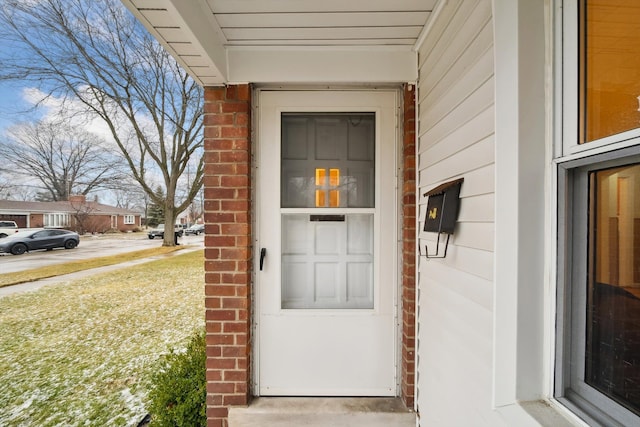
280, 113, 375, 208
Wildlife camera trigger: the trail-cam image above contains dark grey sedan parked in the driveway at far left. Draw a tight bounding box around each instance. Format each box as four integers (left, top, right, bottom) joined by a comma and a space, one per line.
0, 228, 80, 255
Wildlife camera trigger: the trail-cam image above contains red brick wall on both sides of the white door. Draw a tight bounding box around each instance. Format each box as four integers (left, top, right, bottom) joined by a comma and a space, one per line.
205, 85, 416, 427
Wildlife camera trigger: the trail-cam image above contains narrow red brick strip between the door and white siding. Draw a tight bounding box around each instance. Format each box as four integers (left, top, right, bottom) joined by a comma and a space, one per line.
400, 85, 416, 408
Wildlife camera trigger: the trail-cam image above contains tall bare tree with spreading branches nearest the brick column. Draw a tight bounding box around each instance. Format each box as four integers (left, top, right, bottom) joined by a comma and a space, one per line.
0, 0, 203, 246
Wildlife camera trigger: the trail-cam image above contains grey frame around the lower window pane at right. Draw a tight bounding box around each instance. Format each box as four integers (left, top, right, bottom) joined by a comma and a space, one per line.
554, 147, 640, 425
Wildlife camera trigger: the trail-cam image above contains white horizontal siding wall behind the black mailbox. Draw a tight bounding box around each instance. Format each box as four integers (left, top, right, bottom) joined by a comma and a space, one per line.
417, 0, 504, 426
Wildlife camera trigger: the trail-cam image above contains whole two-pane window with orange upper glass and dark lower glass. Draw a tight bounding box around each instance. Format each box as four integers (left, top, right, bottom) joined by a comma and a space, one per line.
555, 0, 640, 426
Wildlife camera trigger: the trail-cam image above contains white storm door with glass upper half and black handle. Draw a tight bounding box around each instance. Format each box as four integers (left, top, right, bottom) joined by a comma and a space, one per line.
256, 91, 397, 396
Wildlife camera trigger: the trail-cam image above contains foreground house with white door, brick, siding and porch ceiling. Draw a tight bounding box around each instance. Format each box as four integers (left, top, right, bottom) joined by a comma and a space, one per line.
122, 0, 640, 427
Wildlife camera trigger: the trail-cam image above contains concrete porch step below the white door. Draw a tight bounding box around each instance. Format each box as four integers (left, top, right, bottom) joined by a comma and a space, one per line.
229, 397, 416, 427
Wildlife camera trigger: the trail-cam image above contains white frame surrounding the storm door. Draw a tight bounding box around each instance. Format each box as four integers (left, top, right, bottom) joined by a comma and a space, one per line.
250, 86, 403, 396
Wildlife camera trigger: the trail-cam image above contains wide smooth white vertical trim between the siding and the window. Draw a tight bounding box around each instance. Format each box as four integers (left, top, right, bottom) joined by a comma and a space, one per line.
492, 0, 586, 426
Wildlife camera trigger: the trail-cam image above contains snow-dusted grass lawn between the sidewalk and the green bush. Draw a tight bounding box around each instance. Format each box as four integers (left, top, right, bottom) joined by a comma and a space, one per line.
0, 251, 204, 426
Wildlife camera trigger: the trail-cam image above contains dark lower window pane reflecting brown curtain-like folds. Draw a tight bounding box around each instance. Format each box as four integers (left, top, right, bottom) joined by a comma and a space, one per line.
585, 164, 640, 413
